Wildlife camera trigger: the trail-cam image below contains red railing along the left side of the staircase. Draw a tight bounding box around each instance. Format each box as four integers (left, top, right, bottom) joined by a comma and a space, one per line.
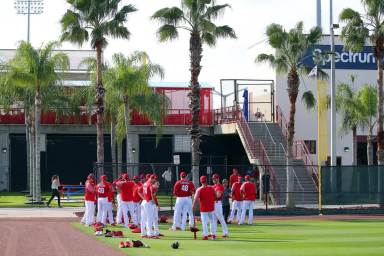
236, 111, 280, 204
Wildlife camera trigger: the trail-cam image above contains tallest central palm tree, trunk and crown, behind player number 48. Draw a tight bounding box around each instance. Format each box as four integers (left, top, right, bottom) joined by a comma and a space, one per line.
152, 0, 236, 185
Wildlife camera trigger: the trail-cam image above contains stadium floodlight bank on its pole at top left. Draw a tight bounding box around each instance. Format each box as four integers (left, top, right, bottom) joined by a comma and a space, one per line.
15, 0, 44, 43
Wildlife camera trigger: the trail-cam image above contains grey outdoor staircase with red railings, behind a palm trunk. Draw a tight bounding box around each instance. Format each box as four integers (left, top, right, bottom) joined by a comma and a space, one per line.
234, 106, 318, 206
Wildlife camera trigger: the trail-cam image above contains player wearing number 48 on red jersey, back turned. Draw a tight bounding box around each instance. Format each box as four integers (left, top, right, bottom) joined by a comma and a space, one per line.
171, 171, 195, 231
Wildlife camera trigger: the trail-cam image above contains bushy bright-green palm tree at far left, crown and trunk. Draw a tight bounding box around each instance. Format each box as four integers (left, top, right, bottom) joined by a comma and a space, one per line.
7, 41, 69, 202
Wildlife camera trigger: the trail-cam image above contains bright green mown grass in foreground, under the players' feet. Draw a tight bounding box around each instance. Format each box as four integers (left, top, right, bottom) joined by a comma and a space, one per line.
73, 219, 384, 256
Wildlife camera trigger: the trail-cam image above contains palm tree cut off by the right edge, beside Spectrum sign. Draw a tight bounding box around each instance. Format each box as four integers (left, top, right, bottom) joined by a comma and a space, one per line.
340, 0, 384, 165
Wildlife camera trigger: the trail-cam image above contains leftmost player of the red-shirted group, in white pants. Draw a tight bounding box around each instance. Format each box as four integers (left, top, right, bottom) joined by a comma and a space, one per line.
81, 174, 96, 226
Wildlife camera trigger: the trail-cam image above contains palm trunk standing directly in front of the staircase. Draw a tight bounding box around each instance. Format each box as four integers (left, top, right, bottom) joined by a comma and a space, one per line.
286, 69, 300, 208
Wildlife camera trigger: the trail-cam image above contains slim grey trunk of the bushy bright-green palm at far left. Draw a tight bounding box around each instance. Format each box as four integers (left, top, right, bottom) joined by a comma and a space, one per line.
35, 88, 41, 202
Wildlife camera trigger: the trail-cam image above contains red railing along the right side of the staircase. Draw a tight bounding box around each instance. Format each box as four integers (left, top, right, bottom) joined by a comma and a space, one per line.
276, 105, 319, 190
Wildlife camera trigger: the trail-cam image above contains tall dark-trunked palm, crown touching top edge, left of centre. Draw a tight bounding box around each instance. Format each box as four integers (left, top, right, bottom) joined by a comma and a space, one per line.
60, 0, 137, 174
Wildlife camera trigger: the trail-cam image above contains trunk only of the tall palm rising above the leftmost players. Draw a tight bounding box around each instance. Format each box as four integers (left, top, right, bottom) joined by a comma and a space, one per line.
96, 43, 105, 177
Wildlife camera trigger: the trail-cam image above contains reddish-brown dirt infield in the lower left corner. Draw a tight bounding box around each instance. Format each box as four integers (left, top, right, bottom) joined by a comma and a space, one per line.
0, 218, 123, 256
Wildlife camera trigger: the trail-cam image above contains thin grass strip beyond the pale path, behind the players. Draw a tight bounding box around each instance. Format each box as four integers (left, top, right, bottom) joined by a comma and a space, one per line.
0, 192, 175, 208
